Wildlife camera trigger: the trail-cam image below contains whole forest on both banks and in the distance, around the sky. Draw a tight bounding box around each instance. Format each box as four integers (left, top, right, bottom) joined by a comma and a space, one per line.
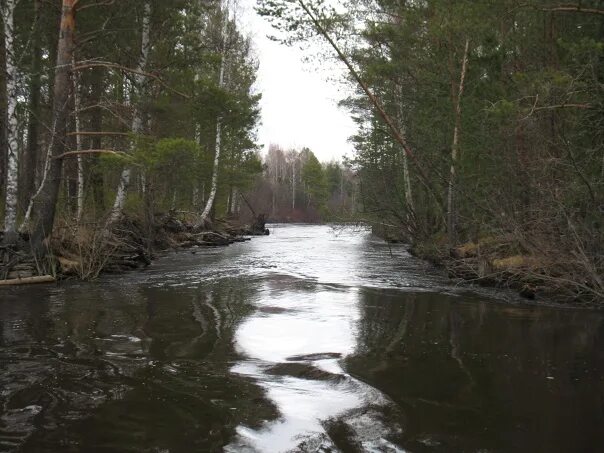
0, 0, 604, 300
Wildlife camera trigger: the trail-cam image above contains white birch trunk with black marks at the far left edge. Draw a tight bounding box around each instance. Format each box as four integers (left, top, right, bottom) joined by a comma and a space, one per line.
2, 0, 19, 242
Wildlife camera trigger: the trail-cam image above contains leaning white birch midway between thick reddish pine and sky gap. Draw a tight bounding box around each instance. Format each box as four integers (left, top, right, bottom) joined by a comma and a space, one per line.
108, 1, 151, 224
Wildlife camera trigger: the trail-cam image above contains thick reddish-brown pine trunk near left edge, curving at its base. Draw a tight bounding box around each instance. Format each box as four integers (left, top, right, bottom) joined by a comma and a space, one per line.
26, 0, 78, 255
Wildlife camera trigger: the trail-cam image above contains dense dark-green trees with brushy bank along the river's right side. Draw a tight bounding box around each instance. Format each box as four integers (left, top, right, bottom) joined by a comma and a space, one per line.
259, 0, 604, 301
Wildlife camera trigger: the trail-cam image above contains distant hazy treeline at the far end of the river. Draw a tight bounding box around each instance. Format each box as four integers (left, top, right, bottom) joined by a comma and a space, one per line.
248, 144, 360, 222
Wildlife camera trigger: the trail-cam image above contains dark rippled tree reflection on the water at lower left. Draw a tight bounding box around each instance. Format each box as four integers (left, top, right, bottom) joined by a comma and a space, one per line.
0, 279, 274, 451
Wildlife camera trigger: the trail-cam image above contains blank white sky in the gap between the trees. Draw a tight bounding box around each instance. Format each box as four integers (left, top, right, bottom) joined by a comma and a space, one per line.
238, 0, 356, 161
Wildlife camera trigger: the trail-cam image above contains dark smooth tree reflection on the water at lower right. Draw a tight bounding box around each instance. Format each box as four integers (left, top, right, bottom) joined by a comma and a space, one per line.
345, 290, 604, 452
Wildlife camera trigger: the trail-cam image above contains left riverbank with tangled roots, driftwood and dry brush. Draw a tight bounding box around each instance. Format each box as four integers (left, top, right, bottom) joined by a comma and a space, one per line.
0, 212, 268, 286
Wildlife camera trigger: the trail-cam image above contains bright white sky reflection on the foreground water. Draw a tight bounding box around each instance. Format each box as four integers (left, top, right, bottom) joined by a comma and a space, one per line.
227, 279, 401, 452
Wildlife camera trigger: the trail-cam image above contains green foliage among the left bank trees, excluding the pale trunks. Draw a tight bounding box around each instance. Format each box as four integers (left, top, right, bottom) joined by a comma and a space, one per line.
0, 0, 262, 233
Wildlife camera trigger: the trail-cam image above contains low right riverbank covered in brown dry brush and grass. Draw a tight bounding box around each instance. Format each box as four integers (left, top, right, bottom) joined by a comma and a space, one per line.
372, 224, 604, 308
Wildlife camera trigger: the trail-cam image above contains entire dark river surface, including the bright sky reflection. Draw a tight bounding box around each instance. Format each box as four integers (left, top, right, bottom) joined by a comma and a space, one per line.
0, 225, 604, 452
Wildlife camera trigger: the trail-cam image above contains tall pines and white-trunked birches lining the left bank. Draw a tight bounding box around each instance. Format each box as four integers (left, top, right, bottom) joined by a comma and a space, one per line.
0, 0, 262, 254
